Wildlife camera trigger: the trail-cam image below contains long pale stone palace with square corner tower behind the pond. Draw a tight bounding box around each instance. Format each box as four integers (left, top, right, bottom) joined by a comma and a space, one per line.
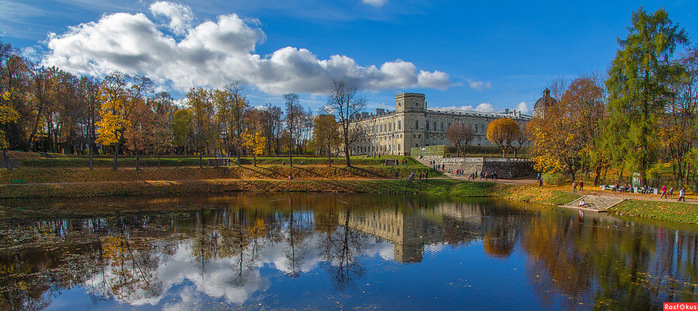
352, 93, 531, 155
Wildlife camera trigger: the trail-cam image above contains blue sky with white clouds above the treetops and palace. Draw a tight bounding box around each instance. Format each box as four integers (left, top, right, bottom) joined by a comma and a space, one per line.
0, 0, 698, 111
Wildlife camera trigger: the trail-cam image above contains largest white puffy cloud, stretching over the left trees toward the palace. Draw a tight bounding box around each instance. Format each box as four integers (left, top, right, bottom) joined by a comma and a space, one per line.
42, 1, 451, 95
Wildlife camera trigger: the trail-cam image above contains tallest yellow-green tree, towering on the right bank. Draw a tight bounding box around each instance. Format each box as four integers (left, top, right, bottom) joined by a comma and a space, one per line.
604, 8, 688, 184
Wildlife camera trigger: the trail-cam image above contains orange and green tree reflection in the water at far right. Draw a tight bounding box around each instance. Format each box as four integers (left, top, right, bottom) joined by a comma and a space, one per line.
522, 212, 698, 310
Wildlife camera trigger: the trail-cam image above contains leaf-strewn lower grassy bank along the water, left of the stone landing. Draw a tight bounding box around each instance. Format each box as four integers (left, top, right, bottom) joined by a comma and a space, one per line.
0, 174, 574, 208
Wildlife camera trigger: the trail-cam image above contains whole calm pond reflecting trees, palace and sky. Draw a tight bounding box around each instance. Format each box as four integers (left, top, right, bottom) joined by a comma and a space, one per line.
0, 193, 698, 310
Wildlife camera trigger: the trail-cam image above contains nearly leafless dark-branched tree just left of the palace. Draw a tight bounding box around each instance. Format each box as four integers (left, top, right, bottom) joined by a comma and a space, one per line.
324, 81, 366, 166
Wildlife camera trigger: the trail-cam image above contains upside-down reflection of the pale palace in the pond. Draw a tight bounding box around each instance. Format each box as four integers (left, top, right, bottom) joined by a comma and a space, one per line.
339, 202, 482, 263
